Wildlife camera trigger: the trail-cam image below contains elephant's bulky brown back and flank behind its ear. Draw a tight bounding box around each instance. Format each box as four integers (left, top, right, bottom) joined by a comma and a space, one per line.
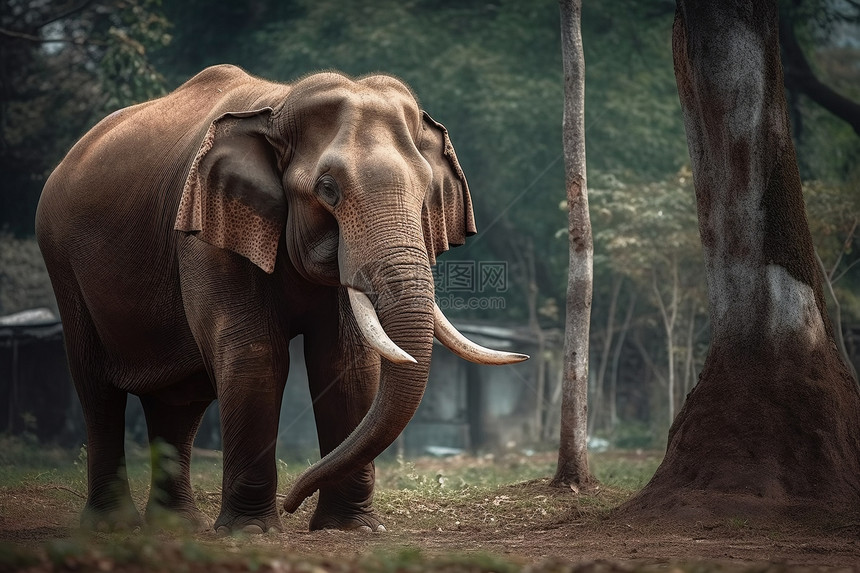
36, 69, 278, 364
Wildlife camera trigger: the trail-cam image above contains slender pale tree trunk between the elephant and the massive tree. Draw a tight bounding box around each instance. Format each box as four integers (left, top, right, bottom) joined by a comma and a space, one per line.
552, 0, 594, 489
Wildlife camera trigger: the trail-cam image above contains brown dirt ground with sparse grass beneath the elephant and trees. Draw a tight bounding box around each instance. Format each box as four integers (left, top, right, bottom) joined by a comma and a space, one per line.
0, 455, 860, 573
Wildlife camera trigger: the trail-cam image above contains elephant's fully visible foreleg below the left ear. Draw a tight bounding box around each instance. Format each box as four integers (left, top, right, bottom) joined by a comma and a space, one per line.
179, 236, 289, 533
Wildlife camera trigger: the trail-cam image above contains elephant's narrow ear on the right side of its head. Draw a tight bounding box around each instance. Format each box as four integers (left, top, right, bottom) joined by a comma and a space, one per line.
418, 112, 477, 264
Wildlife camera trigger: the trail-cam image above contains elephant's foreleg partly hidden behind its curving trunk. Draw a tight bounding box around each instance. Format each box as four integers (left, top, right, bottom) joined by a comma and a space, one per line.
305, 294, 384, 531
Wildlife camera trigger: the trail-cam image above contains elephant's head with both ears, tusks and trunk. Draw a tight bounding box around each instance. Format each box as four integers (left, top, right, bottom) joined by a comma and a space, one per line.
176, 73, 526, 511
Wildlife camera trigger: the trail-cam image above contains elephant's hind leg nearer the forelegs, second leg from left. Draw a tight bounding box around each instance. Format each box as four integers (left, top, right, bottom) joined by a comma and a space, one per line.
140, 396, 212, 531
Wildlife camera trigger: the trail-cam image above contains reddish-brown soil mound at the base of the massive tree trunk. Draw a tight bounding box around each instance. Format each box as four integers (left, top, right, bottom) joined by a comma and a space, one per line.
618, 349, 860, 524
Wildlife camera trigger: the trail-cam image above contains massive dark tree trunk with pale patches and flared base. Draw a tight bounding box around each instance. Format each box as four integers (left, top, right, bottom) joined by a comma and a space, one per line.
623, 0, 860, 520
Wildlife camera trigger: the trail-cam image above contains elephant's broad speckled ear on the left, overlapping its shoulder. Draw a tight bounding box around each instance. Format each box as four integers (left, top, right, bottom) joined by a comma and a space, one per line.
174, 108, 287, 273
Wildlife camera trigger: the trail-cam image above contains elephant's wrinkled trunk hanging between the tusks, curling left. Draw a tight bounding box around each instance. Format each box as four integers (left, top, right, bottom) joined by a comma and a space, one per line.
284, 255, 434, 513
